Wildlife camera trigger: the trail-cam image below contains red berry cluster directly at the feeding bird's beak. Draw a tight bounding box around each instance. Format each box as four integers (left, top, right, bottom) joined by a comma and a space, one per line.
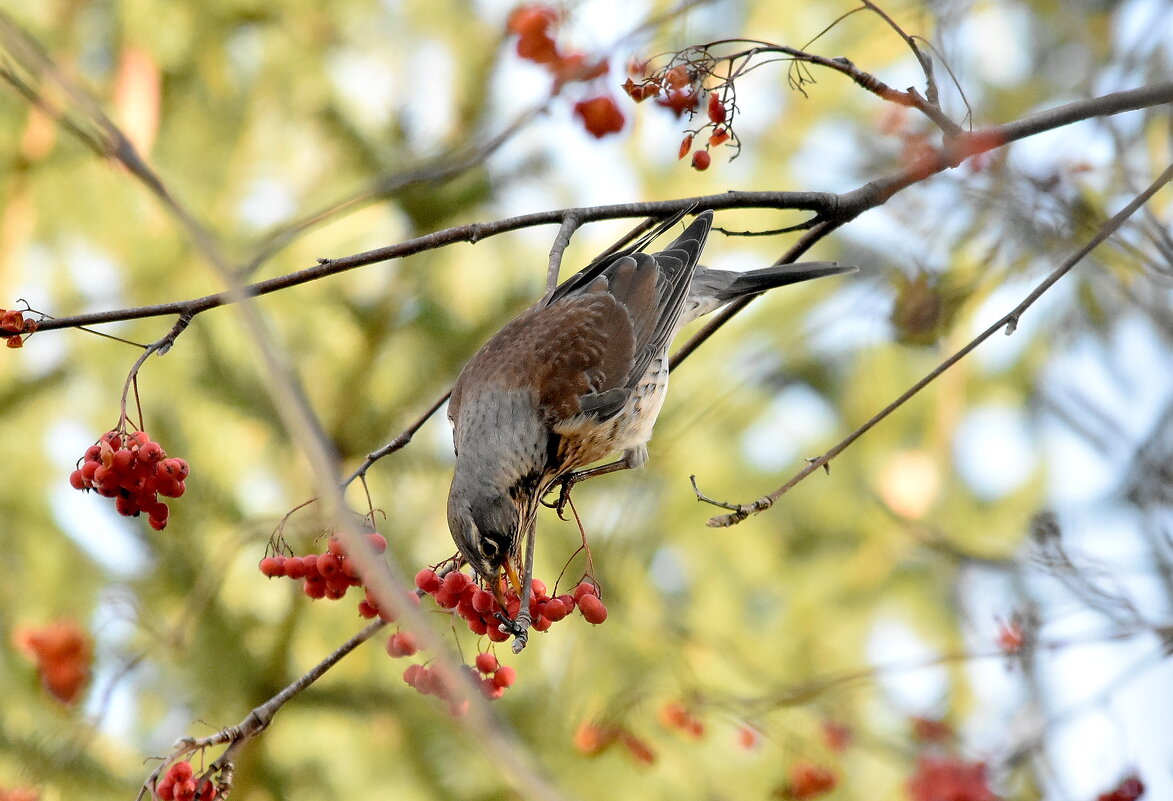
415, 568, 606, 643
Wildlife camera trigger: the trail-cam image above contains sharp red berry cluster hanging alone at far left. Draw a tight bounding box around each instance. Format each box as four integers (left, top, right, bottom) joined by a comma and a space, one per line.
69, 429, 190, 531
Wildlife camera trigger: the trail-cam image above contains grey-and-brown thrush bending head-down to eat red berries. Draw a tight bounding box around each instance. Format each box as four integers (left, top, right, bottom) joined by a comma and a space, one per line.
448, 210, 855, 649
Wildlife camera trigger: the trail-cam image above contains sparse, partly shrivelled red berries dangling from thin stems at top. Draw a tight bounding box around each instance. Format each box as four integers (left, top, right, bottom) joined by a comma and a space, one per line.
623, 49, 741, 171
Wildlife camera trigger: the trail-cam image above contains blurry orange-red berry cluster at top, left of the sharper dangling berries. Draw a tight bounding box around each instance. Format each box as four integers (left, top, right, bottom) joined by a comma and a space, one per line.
506, 4, 624, 138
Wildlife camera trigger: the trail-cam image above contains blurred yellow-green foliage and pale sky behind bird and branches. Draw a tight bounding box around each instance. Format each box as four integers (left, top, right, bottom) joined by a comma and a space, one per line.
0, 0, 1173, 801
